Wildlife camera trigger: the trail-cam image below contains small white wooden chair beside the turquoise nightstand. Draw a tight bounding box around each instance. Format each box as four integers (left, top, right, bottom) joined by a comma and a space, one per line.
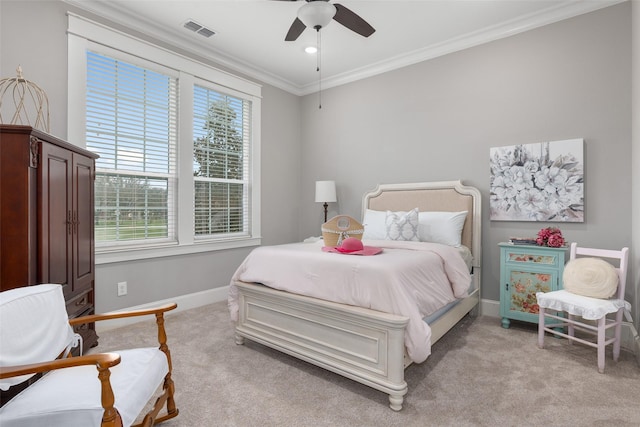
536, 243, 631, 373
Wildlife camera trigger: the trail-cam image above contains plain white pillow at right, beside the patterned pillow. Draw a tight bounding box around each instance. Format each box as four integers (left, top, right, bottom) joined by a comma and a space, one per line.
418, 211, 468, 248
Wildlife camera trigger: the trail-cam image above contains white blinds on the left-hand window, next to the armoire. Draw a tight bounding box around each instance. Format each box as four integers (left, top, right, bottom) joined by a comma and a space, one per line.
86, 52, 177, 245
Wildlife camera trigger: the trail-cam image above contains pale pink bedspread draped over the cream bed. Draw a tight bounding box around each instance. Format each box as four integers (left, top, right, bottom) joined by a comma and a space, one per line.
228, 240, 471, 363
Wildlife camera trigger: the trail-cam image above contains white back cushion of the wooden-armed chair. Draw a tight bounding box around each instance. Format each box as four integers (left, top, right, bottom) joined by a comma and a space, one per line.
0, 284, 74, 390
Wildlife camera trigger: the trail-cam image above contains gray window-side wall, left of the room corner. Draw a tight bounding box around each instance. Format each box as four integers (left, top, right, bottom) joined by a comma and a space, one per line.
0, 0, 301, 312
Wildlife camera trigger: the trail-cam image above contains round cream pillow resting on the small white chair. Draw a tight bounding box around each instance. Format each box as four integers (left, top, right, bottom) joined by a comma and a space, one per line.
562, 258, 618, 298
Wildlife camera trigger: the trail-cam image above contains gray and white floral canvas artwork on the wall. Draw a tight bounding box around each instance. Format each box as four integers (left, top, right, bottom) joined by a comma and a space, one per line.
489, 139, 584, 222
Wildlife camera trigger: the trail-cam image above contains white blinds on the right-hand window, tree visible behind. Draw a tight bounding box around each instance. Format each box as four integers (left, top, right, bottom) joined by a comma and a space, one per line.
193, 85, 251, 238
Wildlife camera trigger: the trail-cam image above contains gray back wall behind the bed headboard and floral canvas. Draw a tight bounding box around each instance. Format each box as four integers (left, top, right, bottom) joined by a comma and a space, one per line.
301, 3, 634, 308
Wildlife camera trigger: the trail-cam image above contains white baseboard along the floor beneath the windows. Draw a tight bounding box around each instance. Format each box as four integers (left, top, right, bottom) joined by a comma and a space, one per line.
96, 286, 229, 334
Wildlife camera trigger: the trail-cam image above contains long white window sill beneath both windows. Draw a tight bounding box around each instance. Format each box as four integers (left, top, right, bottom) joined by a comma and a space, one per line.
96, 237, 261, 265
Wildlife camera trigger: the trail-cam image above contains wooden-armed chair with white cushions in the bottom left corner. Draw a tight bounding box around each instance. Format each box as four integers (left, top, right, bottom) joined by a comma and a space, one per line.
0, 284, 178, 427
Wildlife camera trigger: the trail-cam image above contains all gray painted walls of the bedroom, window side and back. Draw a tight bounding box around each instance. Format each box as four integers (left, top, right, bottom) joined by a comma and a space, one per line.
0, 0, 640, 318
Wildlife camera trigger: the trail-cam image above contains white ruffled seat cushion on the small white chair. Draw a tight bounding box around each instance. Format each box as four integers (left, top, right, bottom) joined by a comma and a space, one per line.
536, 289, 631, 320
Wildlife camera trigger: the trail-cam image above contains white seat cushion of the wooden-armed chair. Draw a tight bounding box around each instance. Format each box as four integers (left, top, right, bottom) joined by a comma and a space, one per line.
0, 348, 169, 427
